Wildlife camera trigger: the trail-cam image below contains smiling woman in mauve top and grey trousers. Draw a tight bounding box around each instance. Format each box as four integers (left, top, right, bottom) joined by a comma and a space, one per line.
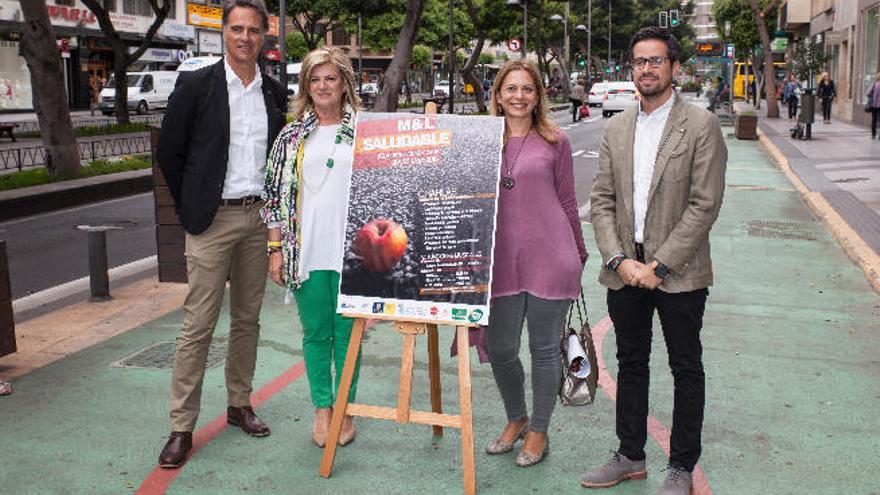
486, 60, 587, 467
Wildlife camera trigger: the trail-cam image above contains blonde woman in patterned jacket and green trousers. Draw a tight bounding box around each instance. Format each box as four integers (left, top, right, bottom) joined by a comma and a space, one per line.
262, 47, 360, 447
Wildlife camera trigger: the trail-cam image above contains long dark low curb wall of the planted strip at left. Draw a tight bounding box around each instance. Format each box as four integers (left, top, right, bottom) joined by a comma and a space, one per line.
0, 168, 153, 221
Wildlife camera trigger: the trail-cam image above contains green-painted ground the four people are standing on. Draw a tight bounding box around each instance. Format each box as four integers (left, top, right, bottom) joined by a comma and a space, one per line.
0, 140, 880, 495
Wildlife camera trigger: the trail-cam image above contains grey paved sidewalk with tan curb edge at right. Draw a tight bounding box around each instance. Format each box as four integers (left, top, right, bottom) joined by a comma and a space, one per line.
735, 102, 880, 291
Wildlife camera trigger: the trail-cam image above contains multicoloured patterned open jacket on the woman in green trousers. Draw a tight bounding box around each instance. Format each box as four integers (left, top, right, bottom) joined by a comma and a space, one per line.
260, 106, 355, 294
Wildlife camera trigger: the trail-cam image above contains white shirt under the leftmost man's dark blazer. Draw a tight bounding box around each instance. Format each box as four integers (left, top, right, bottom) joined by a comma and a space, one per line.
222, 59, 269, 199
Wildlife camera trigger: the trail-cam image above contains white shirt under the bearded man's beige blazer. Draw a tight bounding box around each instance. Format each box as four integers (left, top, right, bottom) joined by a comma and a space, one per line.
633, 95, 675, 244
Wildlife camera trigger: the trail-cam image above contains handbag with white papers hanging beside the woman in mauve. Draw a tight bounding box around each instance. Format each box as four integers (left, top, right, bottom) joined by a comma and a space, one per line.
559, 289, 599, 406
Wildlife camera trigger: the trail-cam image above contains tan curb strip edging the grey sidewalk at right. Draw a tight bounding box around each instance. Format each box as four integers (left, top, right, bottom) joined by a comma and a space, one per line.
757, 128, 880, 294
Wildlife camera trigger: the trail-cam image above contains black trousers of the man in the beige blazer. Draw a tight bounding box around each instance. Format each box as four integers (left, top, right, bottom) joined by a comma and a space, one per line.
608, 286, 709, 471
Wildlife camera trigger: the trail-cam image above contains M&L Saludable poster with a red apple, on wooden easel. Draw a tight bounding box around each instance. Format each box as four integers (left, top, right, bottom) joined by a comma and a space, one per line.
337, 112, 504, 325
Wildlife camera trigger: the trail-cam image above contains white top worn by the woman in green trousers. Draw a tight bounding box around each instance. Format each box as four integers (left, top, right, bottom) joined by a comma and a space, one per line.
297, 124, 352, 281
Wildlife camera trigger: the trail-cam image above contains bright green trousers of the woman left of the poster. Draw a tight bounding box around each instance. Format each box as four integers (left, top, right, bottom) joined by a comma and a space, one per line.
293, 270, 361, 408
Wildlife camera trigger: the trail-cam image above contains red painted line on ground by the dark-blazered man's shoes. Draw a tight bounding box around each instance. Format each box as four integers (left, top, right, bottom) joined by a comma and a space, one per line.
135, 361, 306, 495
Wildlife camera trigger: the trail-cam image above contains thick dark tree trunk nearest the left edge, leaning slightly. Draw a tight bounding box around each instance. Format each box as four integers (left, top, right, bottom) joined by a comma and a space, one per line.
20, 0, 80, 177
